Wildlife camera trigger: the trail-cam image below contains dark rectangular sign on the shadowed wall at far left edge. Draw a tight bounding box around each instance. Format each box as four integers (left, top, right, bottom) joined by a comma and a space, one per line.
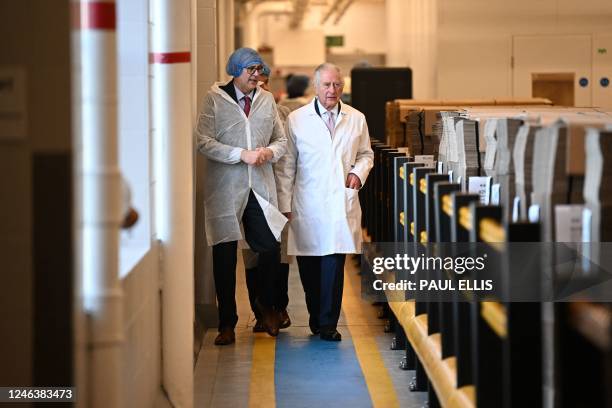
0, 67, 26, 141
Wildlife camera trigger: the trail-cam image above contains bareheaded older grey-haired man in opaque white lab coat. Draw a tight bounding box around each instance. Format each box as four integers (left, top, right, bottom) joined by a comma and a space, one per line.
276, 64, 374, 341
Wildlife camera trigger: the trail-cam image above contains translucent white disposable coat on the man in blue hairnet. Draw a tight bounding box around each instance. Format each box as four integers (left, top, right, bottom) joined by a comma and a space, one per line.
195, 83, 287, 245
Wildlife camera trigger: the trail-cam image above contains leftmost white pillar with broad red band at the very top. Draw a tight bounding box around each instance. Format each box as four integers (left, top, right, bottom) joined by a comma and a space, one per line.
74, 0, 123, 407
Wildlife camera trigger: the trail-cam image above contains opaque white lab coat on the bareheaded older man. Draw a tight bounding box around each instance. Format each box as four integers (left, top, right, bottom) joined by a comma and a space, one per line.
275, 99, 374, 256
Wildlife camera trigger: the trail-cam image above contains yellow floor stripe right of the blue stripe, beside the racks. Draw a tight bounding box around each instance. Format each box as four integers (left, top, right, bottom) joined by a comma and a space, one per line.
342, 271, 399, 408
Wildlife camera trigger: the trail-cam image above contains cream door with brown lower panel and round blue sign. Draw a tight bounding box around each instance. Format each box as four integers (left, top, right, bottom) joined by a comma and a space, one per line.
512, 35, 592, 106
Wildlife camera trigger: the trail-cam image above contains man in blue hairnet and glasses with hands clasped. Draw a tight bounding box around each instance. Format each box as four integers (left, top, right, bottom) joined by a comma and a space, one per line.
195, 48, 287, 345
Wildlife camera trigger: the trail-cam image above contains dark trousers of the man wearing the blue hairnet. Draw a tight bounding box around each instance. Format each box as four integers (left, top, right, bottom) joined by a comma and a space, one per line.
213, 191, 280, 329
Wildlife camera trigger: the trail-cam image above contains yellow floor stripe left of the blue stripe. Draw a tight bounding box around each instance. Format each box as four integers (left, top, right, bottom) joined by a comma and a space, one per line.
249, 333, 276, 408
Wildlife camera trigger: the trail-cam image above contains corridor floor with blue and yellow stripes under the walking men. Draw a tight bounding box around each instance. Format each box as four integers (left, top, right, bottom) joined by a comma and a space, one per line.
194, 257, 426, 408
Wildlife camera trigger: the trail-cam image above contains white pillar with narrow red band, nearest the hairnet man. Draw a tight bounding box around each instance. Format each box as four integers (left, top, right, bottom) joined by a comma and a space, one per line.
150, 0, 194, 408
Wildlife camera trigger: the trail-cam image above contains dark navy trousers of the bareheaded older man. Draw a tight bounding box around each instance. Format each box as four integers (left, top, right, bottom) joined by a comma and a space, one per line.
297, 254, 346, 331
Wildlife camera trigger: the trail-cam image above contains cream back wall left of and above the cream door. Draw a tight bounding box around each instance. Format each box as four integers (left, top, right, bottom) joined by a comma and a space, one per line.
438, 0, 612, 99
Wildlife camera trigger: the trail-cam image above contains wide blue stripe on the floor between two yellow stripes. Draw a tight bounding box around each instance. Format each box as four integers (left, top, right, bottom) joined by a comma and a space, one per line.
274, 327, 372, 408
